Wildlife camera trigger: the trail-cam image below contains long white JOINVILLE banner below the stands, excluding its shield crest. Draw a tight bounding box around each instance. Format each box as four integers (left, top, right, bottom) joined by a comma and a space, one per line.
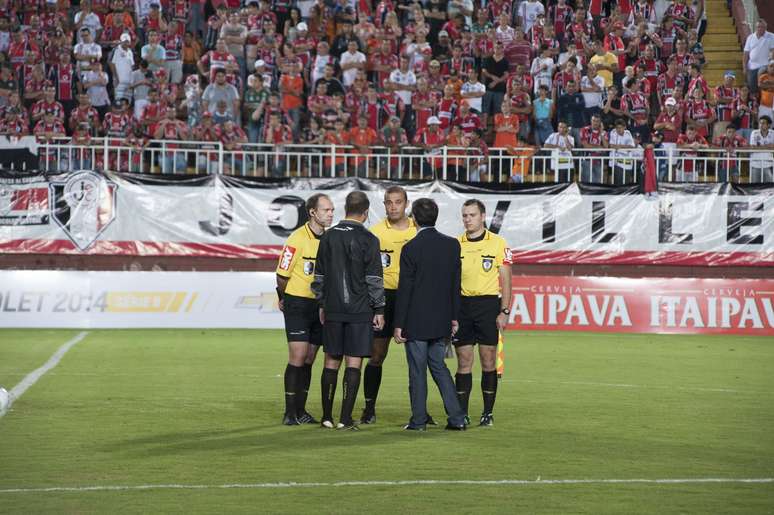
0, 176, 774, 266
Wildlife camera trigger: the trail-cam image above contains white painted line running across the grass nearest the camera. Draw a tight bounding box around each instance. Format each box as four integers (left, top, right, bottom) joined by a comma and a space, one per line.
0, 477, 774, 494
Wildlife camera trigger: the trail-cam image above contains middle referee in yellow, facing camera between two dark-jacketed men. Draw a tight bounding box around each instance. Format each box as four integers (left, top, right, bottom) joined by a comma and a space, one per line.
360, 186, 417, 424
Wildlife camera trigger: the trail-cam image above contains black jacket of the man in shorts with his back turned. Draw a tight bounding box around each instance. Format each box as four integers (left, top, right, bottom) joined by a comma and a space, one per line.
312, 220, 386, 322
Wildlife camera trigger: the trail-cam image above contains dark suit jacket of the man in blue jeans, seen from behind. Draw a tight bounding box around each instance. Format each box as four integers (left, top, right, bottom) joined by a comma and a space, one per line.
394, 227, 462, 340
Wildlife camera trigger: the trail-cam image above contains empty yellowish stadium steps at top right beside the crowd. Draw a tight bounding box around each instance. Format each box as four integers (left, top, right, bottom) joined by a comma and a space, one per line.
702, 0, 744, 86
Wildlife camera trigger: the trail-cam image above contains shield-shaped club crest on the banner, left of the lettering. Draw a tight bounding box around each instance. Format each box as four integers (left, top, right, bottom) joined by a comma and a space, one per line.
49, 171, 118, 251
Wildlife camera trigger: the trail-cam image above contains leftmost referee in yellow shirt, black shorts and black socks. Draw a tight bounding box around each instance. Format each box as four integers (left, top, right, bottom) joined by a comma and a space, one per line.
277, 193, 333, 426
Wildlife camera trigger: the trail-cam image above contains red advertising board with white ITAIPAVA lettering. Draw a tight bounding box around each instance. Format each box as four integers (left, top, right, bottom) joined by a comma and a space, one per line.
509, 276, 774, 336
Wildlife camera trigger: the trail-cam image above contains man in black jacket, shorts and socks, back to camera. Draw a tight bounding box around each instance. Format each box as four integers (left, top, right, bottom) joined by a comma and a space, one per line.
312, 191, 385, 429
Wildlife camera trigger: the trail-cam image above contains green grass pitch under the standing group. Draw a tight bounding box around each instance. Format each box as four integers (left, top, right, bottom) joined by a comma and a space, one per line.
0, 330, 774, 513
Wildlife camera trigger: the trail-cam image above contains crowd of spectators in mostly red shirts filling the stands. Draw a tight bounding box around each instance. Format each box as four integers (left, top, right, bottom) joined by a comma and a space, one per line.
0, 0, 774, 182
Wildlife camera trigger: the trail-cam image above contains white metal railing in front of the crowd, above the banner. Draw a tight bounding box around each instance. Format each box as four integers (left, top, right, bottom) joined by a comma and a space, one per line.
16, 138, 774, 184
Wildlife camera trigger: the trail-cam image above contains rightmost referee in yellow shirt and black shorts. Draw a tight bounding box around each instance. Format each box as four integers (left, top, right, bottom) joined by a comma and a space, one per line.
453, 199, 511, 426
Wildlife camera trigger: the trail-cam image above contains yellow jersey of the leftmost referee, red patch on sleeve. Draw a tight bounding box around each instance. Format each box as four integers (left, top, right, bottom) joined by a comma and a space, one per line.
277, 223, 320, 299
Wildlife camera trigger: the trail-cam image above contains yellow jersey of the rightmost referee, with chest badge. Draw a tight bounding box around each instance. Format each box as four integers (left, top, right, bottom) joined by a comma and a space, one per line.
459, 230, 511, 297
